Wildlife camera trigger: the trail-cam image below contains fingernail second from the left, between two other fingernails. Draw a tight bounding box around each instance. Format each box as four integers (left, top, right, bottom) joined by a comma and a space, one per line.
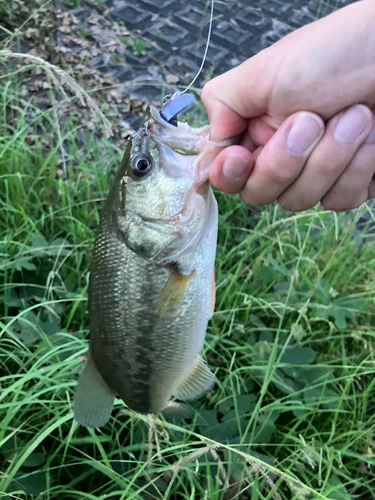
286, 113, 324, 156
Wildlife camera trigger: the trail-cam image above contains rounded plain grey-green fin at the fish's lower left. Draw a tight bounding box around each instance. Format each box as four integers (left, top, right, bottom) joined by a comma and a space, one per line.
74, 358, 115, 428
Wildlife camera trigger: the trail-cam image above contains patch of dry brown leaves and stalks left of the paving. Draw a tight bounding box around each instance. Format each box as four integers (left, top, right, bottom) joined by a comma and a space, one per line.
0, 0, 156, 151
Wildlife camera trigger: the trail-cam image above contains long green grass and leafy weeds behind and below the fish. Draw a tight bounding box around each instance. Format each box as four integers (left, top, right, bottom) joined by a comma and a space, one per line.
0, 29, 375, 500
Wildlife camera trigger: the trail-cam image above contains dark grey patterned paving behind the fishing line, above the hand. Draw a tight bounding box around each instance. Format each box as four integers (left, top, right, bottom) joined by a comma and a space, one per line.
104, 0, 353, 100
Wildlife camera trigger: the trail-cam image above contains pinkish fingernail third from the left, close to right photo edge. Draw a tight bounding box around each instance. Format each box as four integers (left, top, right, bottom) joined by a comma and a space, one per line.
334, 104, 372, 144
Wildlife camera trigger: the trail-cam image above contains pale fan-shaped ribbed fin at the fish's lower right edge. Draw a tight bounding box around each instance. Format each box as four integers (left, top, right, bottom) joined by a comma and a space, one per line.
174, 356, 216, 401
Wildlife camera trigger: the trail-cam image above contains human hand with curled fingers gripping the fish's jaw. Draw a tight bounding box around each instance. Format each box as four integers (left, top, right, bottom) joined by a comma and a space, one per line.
202, 0, 375, 211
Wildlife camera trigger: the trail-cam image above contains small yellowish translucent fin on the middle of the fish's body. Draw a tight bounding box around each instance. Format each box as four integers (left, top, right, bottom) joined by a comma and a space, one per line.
156, 271, 196, 317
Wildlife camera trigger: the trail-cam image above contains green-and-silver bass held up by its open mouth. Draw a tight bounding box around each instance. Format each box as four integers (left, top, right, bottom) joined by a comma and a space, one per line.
74, 97, 225, 428
